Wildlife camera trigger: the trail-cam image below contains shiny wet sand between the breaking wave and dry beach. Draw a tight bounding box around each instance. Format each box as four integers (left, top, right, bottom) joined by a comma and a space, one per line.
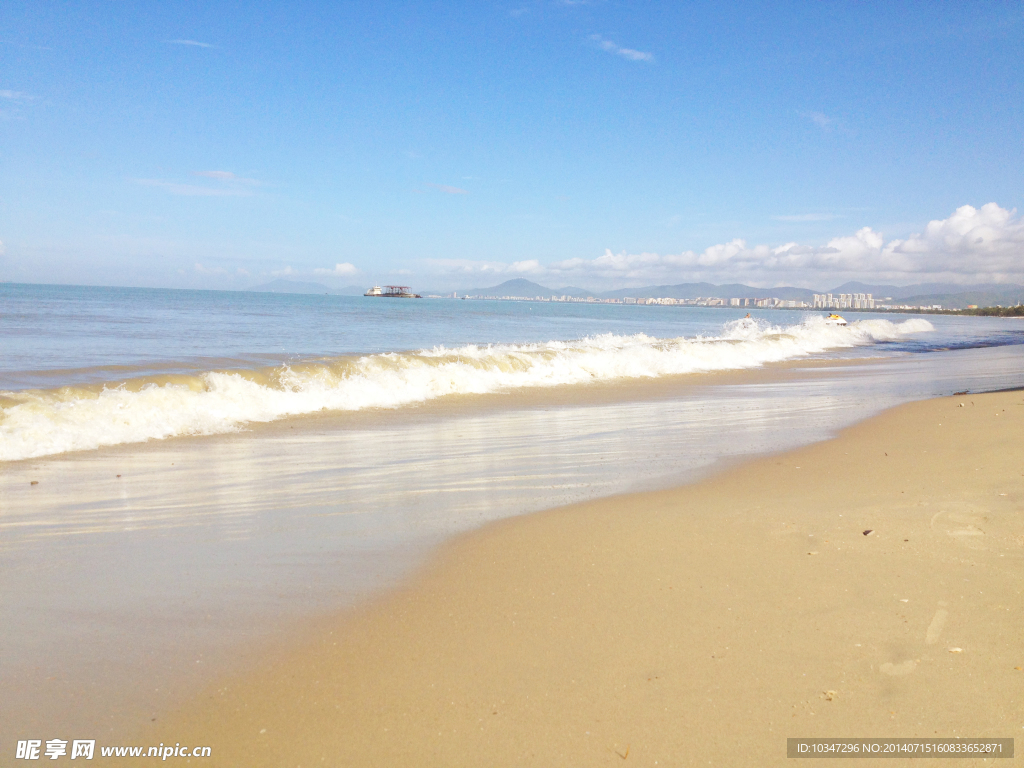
16, 347, 1024, 757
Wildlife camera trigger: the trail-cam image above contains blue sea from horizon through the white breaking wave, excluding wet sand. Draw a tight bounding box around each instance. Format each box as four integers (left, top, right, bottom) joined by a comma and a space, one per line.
0, 284, 1022, 461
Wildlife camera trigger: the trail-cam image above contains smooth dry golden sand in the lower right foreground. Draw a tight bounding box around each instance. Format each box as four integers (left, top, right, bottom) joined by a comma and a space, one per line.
123, 391, 1024, 768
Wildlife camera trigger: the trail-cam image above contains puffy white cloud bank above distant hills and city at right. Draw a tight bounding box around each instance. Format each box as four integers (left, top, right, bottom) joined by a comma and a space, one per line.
428, 203, 1024, 288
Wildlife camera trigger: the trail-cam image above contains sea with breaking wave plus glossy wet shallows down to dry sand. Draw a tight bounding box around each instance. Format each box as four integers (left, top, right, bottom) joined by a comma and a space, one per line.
0, 284, 1024, 741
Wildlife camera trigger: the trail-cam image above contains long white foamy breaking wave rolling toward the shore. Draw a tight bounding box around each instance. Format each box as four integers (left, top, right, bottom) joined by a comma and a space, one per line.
0, 317, 933, 461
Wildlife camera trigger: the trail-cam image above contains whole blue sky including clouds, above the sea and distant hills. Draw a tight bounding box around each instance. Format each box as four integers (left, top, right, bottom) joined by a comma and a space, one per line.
0, 0, 1024, 290
